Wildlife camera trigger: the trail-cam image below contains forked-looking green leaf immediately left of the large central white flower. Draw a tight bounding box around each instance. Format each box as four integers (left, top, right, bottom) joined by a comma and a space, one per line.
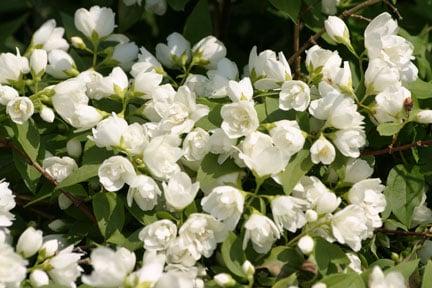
197, 153, 240, 194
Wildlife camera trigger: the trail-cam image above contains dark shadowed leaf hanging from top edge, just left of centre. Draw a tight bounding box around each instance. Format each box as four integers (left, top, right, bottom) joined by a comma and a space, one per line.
183, 0, 212, 43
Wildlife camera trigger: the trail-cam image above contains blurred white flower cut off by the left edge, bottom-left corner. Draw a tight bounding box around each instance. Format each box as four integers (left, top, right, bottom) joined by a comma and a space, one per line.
0, 243, 27, 287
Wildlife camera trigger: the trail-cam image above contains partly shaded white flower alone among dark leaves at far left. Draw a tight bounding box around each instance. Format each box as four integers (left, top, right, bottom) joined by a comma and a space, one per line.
42, 156, 78, 182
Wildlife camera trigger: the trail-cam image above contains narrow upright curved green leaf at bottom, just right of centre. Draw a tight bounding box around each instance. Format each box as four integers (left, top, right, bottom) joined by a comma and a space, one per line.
221, 232, 246, 278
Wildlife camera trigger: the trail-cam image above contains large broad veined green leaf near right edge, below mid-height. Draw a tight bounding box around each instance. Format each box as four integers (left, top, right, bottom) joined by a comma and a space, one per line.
384, 165, 425, 227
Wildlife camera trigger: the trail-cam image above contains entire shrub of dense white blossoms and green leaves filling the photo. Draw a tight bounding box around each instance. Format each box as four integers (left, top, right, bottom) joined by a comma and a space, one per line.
0, 0, 432, 288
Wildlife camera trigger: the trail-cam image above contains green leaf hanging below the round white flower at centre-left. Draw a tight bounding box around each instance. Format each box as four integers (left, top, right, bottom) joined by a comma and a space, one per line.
93, 192, 125, 239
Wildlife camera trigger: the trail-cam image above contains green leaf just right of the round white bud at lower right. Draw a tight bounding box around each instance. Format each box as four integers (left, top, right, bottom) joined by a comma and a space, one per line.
314, 238, 350, 275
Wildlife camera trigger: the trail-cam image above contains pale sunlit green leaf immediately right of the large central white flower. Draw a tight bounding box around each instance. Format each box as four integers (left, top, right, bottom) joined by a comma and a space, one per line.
279, 149, 313, 195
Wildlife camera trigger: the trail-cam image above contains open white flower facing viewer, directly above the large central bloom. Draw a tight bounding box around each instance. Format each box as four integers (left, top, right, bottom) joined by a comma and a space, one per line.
221, 101, 259, 139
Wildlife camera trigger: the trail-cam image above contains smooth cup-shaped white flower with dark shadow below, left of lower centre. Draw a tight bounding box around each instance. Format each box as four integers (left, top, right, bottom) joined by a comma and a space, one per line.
162, 172, 199, 210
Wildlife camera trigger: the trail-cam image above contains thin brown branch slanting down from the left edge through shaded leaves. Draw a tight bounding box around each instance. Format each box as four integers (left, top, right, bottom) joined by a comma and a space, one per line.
0, 139, 97, 223
